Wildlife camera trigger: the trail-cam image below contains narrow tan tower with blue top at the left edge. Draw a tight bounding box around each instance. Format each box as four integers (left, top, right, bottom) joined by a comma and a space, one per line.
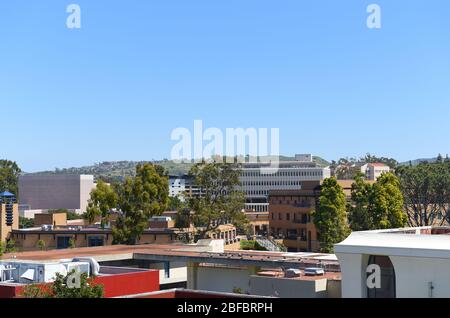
0, 191, 19, 243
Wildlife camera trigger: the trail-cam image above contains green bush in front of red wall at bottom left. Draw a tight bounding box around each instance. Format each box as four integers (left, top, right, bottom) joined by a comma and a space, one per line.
22, 271, 104, 299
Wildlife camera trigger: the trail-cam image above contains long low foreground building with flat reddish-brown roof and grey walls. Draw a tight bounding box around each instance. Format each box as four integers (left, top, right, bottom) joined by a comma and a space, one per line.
0, 240, 341, 298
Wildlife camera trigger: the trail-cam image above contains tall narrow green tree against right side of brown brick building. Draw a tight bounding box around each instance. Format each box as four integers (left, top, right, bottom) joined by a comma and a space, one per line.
312, 178, 350, 253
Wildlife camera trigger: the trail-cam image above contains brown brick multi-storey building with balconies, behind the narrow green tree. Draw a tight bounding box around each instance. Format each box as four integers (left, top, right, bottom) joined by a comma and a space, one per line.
269, 180, 353, 252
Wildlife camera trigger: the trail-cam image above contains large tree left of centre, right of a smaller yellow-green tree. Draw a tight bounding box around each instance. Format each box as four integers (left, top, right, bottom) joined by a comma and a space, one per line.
113, 163, 169, 244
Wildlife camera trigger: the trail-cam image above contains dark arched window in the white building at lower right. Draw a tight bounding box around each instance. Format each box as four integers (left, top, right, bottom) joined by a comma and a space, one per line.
367, 256, 397, 298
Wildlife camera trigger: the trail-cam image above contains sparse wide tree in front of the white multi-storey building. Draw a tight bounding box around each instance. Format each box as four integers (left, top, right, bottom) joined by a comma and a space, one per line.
187, 163, 249, 239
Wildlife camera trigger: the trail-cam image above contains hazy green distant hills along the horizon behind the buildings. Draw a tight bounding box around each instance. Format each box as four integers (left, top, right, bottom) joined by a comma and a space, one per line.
30, 156, 330, 182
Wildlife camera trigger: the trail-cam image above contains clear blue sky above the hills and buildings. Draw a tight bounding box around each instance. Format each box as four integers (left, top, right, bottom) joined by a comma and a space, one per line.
0, 0, 450, 171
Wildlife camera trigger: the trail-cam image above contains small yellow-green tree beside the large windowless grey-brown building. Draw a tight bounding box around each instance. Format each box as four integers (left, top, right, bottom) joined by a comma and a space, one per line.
85, 180, 119, 228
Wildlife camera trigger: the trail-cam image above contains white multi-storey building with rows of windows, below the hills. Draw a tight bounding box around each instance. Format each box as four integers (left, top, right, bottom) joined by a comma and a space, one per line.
239, 155, 331, 212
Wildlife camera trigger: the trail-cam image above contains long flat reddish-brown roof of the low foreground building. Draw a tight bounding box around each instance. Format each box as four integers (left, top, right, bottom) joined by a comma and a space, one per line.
0, 243, 340, 272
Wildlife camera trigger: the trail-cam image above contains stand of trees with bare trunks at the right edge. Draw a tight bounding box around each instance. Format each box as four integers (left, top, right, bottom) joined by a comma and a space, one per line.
396, 158, 450, 227
